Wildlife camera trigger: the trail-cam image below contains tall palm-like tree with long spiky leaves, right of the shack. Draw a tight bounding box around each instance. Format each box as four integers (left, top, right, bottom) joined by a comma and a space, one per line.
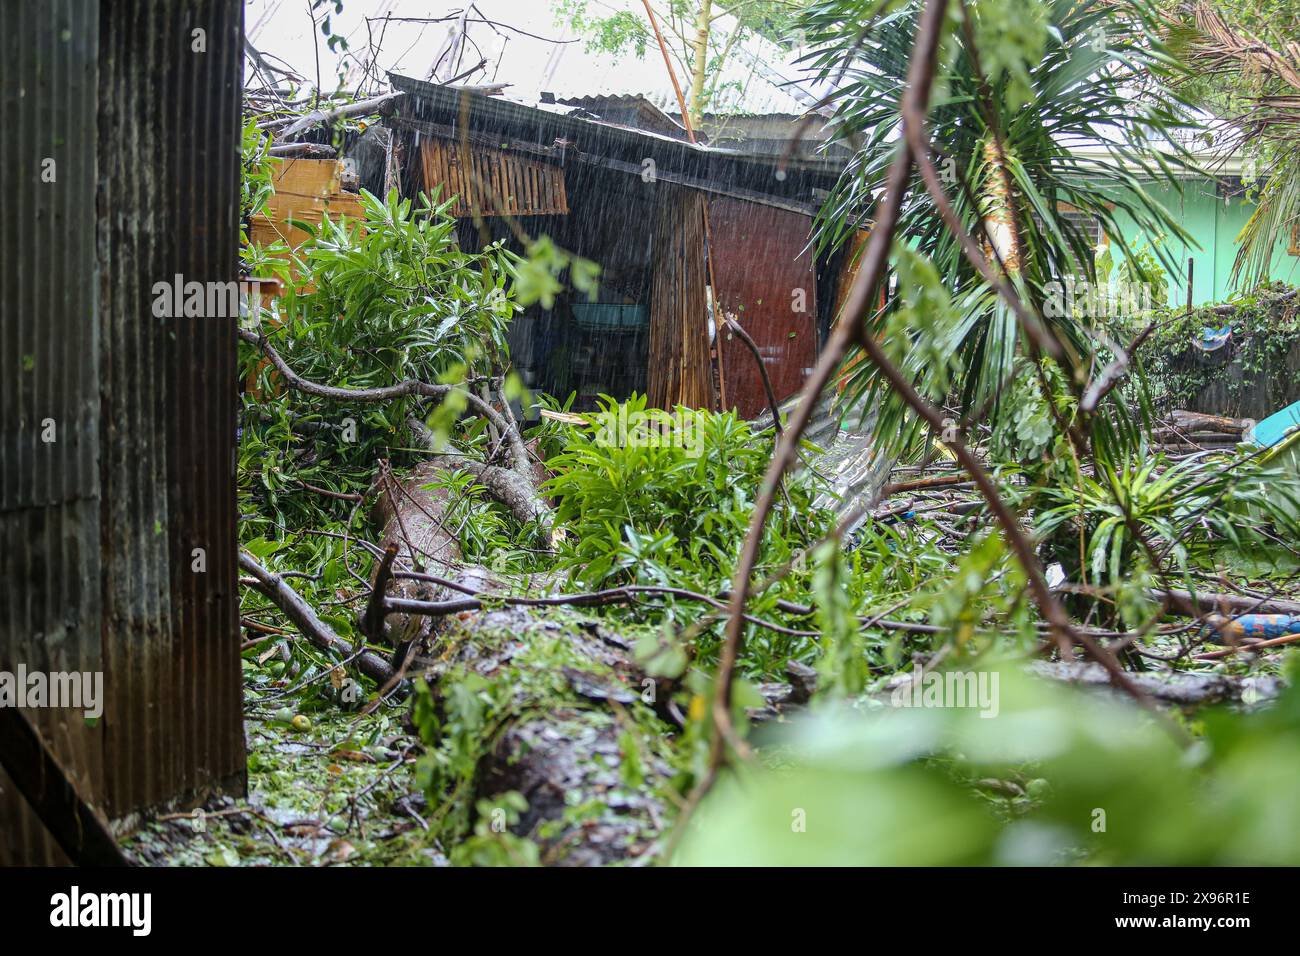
803, 0, 1190, 451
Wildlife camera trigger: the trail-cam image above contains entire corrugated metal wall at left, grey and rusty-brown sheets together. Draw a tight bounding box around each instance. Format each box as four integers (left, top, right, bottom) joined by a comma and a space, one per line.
0, 0, 244, 858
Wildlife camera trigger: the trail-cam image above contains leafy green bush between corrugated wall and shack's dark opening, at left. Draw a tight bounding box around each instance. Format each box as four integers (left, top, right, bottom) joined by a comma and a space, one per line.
241, 184, 515, 524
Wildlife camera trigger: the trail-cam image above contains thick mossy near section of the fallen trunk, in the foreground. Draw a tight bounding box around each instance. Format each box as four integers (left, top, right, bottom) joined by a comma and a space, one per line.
420, 607, 672, 866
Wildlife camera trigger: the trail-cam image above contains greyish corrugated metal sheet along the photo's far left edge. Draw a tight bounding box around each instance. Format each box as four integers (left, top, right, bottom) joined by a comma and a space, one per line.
0, 0, 103, 864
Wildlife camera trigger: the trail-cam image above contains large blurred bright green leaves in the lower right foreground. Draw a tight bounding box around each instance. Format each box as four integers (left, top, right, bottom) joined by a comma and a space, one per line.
676, 667, 1300, 866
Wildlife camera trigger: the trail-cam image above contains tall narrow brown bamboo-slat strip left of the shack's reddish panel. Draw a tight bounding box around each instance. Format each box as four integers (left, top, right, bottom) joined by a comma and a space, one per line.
646, 186, 714, 408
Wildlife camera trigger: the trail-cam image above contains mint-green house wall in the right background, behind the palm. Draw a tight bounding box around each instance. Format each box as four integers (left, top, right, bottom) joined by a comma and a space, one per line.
1097, 179, 1300, 306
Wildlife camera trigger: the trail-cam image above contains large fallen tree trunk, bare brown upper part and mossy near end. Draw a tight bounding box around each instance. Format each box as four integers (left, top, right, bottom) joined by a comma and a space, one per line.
376, 442, 672, 865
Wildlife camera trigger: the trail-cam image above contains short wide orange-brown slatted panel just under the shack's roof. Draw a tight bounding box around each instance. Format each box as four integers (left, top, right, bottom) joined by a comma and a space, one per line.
420, 138, 568, 216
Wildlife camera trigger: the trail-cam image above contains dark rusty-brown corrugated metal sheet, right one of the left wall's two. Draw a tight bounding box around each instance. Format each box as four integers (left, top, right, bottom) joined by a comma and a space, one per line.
99, 0, 244, 814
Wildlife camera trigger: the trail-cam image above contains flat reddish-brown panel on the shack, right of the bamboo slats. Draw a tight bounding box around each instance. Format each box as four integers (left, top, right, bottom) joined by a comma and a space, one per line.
709, 198, 816, 418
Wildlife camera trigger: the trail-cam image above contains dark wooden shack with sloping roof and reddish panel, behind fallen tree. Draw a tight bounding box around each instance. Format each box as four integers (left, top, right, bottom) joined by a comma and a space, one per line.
385, 75, 845, 418
